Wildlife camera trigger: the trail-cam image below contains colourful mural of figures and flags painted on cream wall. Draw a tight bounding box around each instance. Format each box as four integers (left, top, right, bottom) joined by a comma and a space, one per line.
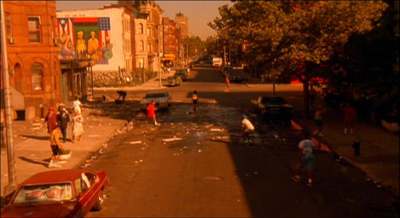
58, 17, 113, 64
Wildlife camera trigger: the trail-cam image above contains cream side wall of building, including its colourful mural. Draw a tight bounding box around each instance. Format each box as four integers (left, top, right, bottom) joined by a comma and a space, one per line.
57, 5, 135, 86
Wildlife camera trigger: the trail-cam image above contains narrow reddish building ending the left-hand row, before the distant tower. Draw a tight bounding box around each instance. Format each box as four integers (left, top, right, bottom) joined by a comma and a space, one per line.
162, 17, 179, 65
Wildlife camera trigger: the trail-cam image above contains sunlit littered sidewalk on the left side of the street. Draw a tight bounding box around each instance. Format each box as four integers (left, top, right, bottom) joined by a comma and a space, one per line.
1, 105, 127, 196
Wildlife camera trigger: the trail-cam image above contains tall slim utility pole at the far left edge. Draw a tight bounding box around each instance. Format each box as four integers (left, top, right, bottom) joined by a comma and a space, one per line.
0, 1, 16, 194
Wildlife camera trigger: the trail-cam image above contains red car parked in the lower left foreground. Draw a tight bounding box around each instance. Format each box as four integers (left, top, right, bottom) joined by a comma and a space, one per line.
1, 169, 108, 218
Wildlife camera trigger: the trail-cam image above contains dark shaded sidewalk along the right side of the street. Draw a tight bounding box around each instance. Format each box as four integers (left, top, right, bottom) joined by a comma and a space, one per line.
298, 109, 400, 196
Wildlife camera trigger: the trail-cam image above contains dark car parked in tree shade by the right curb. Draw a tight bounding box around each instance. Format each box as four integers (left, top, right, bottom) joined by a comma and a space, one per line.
252, 96, 293, 124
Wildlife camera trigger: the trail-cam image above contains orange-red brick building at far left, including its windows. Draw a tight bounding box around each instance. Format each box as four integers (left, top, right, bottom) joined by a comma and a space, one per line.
2, 1, 60, 120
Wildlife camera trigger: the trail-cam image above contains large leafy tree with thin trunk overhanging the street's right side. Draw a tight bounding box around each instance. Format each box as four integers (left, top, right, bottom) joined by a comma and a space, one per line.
210, 0, 387, 114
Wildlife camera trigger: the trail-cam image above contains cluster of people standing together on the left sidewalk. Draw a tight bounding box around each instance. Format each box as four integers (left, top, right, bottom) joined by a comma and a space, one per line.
45, 98, 84, 168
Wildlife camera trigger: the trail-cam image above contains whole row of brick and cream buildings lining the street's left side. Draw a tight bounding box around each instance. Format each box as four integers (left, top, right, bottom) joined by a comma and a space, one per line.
1, 0, 188, 119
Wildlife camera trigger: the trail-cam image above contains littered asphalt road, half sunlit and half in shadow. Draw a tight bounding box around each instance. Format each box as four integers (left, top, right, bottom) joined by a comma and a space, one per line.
85, 69, 399, 218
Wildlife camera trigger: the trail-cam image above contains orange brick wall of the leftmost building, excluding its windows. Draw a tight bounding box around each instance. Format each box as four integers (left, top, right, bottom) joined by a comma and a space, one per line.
4, 1, 61, 119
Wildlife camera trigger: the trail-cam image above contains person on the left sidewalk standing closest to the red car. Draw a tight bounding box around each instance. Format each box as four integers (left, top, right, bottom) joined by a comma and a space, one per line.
48, 126, 71, 168
